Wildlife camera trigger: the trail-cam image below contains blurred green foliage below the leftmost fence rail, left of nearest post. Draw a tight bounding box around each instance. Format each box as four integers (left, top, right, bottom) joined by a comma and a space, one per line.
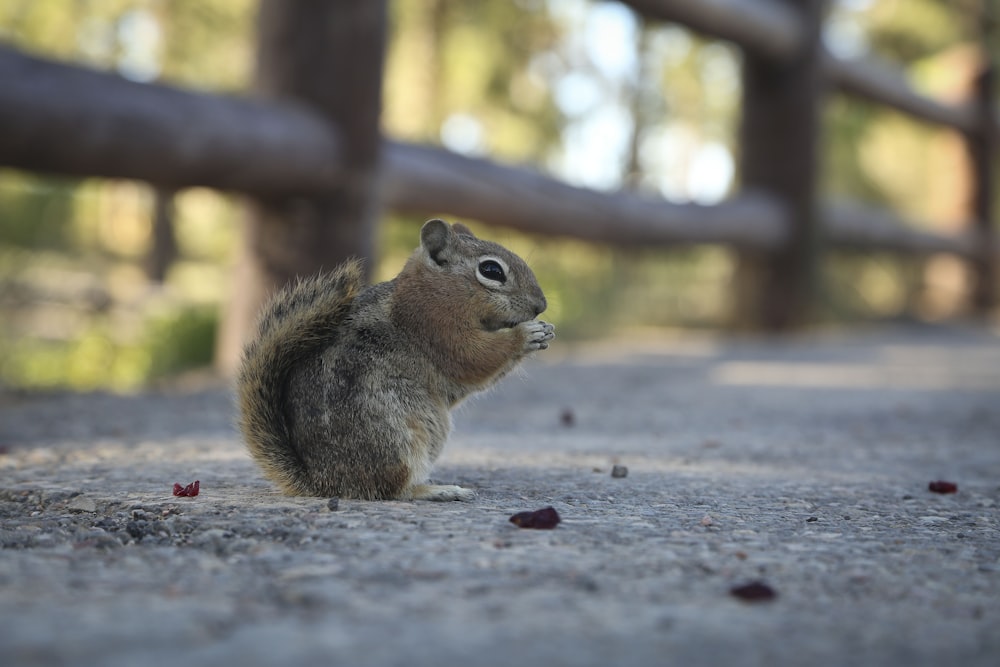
0, 171, 230, 390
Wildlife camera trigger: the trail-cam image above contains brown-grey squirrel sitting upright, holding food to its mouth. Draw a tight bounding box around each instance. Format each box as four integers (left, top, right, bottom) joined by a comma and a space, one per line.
236, 219, 555, 501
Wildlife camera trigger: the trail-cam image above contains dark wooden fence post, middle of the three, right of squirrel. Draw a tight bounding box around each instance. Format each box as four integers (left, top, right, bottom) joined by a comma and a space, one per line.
734, 0, 825, 331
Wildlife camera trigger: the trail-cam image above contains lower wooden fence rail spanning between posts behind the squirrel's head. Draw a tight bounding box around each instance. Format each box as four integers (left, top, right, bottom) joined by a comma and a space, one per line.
384, 142, 788, 249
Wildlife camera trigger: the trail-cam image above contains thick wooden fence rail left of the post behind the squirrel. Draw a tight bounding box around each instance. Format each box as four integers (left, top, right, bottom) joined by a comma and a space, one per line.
0, 46, 344, 195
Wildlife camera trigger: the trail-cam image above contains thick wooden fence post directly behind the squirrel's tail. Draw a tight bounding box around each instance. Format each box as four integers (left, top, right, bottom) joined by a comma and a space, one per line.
216, 0, 386, 374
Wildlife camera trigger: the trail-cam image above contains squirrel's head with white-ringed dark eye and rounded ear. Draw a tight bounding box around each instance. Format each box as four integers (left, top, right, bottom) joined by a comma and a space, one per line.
414, 220, 547, 330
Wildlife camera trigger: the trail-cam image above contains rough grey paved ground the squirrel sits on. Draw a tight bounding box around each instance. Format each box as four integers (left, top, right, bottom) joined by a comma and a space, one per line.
0, 330, 1000, 667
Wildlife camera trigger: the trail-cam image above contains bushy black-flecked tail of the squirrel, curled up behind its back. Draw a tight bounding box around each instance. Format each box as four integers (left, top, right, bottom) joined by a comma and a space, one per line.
236, 260, 364, 495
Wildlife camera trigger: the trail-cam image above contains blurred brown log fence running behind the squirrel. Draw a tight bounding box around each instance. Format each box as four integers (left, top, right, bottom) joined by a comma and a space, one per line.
0, 0, 1000, 365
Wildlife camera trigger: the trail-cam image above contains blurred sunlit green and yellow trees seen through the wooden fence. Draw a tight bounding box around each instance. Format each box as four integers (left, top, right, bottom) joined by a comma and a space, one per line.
0, 0, 996, 391
